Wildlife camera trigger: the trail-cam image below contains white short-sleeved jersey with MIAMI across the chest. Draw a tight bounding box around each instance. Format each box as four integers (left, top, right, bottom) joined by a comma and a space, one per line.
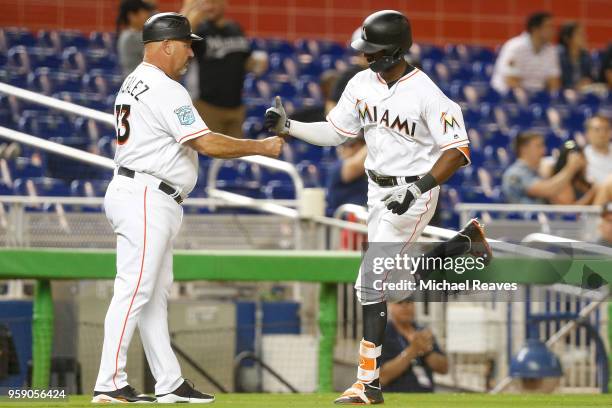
327, 68, 469, 176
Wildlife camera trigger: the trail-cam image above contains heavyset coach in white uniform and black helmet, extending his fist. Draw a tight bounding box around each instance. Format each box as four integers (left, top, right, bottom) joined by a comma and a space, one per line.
92, 13, 283, 403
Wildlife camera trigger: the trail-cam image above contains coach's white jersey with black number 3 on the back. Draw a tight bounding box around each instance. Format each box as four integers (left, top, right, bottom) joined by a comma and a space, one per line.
114, 62, 210, 196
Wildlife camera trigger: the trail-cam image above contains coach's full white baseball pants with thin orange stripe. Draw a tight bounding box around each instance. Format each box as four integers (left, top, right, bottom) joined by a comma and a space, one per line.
95, 173, 183, 394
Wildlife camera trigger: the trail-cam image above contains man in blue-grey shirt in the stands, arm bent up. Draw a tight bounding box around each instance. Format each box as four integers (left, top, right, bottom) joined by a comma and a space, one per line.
502, 132, 586, 204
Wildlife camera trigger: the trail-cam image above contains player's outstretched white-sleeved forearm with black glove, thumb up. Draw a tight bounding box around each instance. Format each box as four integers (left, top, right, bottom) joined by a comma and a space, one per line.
264, 96, 348, 146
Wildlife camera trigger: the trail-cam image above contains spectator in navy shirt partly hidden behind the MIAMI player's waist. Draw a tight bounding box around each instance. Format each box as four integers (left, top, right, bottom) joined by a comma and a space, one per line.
327, 136, 368, 216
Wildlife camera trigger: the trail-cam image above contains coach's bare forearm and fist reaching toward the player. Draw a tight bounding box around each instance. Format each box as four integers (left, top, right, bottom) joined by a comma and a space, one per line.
185, 132, 284, 159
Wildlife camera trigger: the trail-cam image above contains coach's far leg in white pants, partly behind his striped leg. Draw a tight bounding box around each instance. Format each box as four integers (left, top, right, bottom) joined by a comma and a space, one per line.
138, 239, 183, 395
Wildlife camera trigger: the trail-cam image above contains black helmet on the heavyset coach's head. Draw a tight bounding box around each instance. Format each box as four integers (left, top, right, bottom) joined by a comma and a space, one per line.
142, 13, 202, 44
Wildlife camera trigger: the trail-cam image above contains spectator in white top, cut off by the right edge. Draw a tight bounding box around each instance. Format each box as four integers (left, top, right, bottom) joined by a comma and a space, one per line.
584, 115, 612, 184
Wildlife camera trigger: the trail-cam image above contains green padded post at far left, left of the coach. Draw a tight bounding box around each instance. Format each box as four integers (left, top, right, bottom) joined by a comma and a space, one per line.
32, 279, 54, 389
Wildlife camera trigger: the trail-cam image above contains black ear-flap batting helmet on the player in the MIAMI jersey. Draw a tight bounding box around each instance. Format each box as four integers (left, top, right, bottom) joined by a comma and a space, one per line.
351, 10, 412, 72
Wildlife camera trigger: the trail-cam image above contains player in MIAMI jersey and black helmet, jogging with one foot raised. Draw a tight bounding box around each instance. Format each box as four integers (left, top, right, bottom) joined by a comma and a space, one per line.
265, 10, 490, 404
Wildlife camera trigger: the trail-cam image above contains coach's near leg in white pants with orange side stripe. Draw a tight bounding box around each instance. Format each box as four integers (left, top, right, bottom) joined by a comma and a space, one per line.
94, 181, 176, 394
